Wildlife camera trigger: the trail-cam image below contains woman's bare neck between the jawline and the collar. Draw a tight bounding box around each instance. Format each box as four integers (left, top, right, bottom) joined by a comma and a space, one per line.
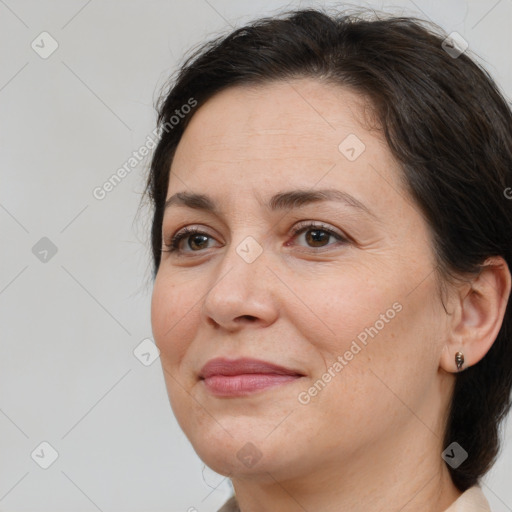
232, 418, 461, 512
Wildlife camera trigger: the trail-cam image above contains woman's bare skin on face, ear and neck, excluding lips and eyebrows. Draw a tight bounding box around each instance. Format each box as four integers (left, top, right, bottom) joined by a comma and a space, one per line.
152, 79, 510, 512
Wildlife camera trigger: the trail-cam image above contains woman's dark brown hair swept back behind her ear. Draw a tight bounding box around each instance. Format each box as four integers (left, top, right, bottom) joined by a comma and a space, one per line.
146, 5, 512, 491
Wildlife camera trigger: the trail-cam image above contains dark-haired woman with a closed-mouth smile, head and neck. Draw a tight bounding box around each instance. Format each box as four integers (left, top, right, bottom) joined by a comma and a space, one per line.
144, 10, 512, 512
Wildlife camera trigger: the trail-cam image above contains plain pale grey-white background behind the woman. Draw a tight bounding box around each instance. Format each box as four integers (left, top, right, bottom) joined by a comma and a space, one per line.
0, 0, 512, 512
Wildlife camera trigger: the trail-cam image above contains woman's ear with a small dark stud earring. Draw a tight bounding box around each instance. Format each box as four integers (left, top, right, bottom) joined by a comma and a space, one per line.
440, 256, 511, 373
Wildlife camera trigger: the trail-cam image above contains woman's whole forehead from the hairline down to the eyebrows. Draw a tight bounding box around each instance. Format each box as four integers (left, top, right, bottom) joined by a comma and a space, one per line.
167, 79, 408, 216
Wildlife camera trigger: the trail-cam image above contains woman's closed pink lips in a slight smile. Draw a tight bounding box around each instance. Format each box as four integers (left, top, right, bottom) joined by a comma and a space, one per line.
199, 358, 303, 397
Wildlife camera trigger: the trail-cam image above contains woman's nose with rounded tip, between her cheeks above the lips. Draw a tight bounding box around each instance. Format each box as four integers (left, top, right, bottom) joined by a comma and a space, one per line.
202, 239, 279, 331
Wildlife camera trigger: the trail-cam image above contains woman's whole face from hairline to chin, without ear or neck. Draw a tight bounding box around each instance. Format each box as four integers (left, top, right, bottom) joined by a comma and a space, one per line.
152, 79, 449, 478
